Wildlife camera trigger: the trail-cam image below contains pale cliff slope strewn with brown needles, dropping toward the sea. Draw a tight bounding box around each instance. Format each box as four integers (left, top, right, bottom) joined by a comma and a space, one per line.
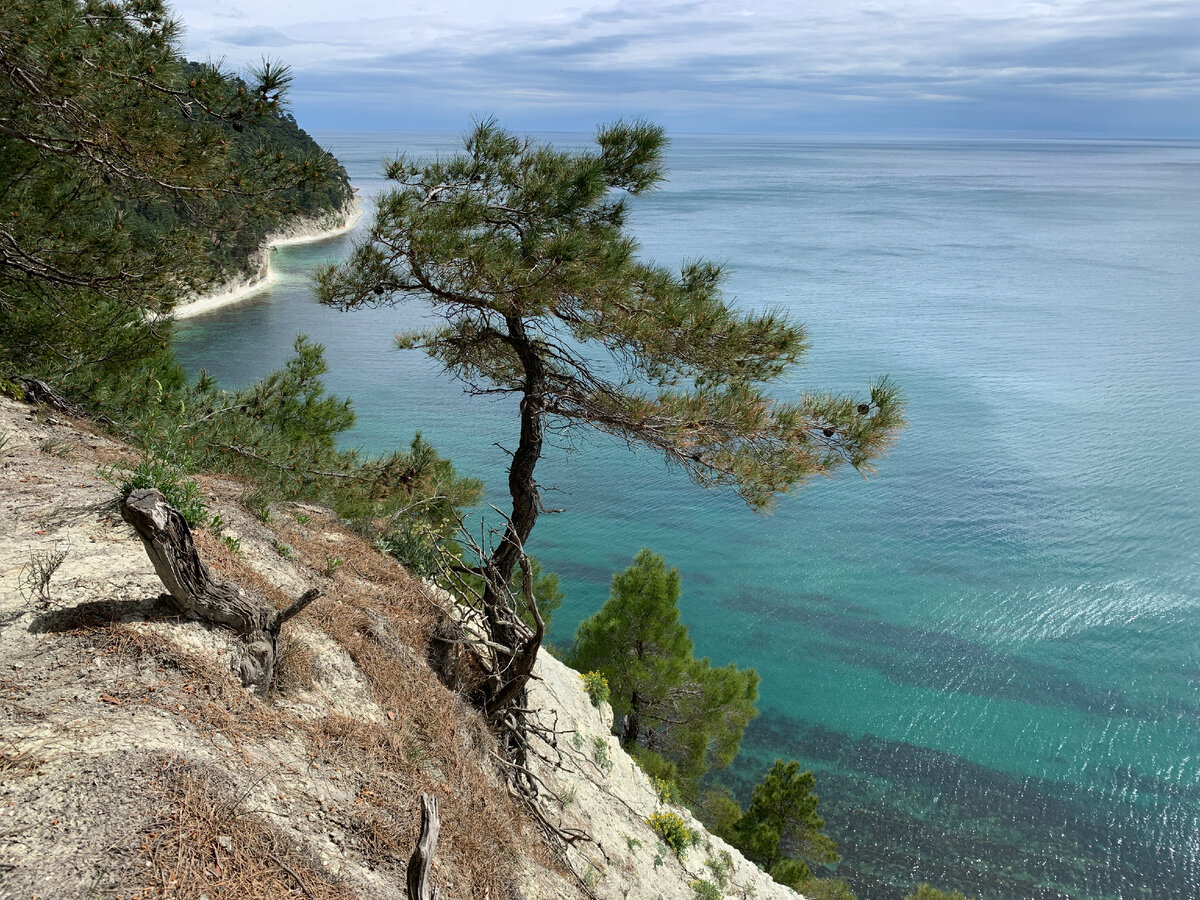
0, 397, 797, 900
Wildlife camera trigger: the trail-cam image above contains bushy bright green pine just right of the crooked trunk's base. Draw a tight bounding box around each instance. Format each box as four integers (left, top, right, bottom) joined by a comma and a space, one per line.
570, 550, 758, 780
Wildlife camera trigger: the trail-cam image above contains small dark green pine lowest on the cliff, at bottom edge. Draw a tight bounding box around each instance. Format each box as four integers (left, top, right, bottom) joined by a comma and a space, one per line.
731, 760, 839, 887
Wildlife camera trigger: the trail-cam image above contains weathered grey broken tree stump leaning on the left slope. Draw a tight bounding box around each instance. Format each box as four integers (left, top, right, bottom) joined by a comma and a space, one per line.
121, 487, 320, 694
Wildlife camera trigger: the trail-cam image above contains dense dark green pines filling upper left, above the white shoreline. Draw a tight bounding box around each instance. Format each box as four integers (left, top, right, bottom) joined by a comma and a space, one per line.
0, 0, 350, 384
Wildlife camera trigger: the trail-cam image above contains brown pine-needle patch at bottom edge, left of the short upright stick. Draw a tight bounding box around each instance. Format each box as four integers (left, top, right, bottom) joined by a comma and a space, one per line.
140, 760, 355, 900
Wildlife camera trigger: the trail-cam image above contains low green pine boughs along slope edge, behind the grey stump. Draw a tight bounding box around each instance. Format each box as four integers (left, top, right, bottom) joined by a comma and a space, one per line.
84, 337, 482, 574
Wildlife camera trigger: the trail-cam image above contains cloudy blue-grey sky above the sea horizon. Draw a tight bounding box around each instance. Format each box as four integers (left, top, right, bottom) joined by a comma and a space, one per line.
166, 0, 1200, 137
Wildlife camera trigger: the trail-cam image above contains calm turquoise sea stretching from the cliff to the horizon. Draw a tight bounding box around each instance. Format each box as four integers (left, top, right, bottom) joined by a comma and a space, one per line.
176, 134, 1200, 900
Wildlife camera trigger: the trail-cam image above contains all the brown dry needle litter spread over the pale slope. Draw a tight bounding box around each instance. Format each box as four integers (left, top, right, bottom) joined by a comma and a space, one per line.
48, 480, 557, 900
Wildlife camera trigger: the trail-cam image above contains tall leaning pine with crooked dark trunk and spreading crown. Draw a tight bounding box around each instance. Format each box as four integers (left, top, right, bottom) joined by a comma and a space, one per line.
318, 121, 904, 724
